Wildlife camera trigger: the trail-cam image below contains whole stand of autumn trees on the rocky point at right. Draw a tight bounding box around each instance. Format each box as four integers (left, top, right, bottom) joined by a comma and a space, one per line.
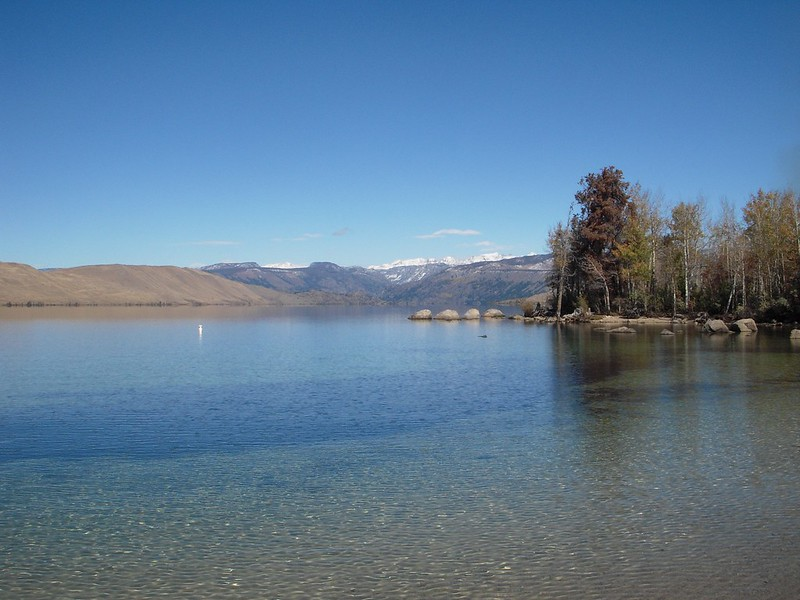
548, 166, 800, 321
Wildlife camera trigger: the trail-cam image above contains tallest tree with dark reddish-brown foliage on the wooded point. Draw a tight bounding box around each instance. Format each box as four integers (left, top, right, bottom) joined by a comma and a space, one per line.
571, 166, 629, 313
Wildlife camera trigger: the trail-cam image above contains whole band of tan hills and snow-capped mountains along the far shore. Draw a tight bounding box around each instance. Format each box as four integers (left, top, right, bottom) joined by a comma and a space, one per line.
0, 255, 551, 306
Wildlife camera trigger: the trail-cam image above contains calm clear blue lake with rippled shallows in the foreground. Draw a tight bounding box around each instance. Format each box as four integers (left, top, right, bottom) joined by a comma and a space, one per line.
0, 308, 800, 599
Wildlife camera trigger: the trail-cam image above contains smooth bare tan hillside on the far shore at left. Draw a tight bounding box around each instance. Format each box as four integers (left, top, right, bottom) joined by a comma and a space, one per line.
0, 263, 293, 305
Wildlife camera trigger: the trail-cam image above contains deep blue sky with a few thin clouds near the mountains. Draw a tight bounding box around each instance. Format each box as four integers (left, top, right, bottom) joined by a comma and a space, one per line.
0, 0, 800, 267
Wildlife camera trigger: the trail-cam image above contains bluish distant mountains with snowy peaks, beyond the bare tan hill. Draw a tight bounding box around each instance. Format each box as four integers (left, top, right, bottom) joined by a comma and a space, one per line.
202, 254, 552, 306
